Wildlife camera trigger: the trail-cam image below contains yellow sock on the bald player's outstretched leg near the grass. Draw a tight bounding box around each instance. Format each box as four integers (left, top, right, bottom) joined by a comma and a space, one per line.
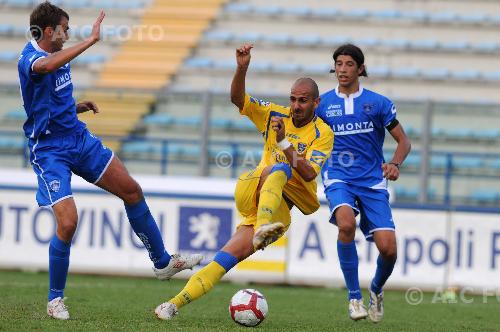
168, 262, 226, 309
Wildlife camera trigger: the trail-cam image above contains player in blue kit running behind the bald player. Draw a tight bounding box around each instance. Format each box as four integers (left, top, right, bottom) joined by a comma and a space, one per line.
316, 44, 411, 322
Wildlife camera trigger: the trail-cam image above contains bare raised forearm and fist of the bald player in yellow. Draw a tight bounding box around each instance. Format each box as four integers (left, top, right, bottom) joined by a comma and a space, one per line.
231, 44, 253, 110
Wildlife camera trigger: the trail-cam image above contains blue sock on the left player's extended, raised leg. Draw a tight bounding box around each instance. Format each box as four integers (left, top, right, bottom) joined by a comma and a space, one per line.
125, 198, 170, 269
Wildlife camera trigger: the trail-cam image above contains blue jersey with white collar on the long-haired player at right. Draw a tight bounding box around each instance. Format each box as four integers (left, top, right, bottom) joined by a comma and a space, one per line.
316, 86, 396, 189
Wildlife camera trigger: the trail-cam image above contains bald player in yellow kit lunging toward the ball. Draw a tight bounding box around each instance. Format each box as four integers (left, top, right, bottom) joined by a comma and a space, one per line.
155, 44, 333, 320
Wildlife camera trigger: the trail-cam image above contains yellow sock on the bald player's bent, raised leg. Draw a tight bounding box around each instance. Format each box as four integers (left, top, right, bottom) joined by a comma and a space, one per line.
257, 171, 288, 224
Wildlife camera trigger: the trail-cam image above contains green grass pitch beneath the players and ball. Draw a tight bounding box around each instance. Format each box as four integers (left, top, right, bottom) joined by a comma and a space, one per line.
0, 271, 500, 332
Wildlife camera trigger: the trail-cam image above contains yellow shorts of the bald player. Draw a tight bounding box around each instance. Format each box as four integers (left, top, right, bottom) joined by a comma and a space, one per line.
234, 167, 291, 231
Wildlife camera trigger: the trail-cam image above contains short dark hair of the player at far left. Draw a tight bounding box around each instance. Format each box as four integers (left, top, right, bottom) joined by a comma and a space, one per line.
30, 1, 69, 41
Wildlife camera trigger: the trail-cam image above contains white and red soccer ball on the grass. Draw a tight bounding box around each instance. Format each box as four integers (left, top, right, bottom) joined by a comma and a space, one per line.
229, 289, 268, 326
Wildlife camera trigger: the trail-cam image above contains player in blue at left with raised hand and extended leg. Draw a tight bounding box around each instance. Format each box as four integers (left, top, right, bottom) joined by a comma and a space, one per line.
18, 2, 202, 320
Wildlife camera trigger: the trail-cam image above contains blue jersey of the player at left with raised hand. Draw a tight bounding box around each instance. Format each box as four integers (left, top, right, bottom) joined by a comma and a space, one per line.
17, 40, 85, 139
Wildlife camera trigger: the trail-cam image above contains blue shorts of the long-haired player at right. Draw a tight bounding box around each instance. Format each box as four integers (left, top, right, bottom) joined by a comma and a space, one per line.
325, 182, 396, 242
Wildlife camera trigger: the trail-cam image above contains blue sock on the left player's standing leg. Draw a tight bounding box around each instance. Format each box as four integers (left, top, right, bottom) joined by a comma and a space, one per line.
48, 235, 71, 302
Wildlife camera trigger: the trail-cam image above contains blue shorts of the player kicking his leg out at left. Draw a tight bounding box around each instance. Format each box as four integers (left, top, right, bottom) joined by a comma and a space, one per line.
29, 129, 113, 206
